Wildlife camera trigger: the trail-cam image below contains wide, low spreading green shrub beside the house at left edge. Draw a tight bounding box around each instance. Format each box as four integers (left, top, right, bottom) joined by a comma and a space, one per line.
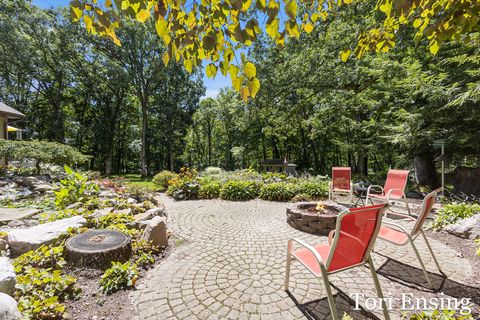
0, 140, 90, 172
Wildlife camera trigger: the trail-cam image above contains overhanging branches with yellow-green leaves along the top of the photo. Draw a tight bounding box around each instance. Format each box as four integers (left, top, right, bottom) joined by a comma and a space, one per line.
71, 0, 480, 100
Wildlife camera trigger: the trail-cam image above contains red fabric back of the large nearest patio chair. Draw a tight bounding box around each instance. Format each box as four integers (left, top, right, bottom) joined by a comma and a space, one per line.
326, 204, 387, 272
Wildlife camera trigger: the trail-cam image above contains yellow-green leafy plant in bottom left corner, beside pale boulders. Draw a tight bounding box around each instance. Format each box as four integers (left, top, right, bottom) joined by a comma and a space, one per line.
15, 267, 80, 319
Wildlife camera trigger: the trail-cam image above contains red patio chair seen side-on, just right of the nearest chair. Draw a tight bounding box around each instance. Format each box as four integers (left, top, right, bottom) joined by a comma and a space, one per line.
378, 188, 446, 289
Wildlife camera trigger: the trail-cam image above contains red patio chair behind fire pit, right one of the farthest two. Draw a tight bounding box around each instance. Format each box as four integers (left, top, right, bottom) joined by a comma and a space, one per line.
365, 169, 410, 214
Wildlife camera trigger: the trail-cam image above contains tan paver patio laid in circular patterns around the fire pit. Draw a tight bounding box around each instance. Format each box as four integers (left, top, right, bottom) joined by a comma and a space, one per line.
132, 197, 477, 320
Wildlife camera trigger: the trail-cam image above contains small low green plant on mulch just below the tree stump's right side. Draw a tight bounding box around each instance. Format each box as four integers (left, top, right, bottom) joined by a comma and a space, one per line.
100, 261, 139, 294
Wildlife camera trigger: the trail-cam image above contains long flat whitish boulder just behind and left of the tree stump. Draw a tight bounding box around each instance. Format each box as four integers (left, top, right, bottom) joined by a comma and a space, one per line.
8, 216, 87, 253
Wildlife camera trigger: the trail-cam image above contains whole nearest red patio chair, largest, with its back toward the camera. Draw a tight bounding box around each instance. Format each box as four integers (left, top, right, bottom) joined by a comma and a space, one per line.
285, 204, 390, 320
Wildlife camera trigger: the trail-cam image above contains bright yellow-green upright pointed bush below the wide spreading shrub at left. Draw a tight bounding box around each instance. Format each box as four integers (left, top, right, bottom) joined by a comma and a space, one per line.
54, 165, 98, 208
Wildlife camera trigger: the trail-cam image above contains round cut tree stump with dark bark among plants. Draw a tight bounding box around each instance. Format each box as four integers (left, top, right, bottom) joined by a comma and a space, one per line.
65, 230, 132, 269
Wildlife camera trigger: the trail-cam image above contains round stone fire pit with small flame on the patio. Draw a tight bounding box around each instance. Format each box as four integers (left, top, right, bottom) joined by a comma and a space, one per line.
287, 202, 346, 236
